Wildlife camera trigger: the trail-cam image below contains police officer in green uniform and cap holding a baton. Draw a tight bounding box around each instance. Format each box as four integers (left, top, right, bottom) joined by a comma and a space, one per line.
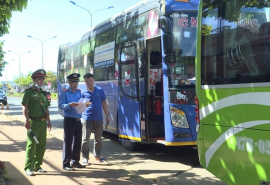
22, 69, 51, 176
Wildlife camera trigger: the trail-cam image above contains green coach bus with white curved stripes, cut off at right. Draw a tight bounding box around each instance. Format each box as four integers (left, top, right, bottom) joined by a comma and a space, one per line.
195, 0, 270, 185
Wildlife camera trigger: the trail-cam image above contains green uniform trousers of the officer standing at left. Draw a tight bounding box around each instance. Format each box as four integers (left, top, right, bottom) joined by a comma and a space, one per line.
24, 120, 47, 171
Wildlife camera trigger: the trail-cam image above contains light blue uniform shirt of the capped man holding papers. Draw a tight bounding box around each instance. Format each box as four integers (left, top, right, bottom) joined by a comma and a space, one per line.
58, 87, 82, 118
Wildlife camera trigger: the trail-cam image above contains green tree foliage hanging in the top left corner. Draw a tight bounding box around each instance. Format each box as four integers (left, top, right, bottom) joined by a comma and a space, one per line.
0, 0, 28, 35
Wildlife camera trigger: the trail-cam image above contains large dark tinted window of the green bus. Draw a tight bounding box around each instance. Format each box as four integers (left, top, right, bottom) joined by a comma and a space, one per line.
201, 0, 270, 85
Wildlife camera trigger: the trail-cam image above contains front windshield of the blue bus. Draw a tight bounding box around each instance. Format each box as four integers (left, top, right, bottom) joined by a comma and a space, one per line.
168, 12, 197, 88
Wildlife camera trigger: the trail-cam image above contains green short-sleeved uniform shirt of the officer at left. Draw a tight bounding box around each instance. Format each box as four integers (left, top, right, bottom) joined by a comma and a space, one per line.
22, 87, 50, 118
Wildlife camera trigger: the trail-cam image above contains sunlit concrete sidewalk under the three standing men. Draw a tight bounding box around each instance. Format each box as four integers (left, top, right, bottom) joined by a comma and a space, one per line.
0, 114, 155, 185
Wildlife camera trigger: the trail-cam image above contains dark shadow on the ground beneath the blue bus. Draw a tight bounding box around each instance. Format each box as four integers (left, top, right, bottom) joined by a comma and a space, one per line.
100, 132, 200, 166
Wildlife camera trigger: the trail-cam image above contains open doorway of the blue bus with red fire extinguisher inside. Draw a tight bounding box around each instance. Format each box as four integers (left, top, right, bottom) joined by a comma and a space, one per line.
145, 37, 165, 143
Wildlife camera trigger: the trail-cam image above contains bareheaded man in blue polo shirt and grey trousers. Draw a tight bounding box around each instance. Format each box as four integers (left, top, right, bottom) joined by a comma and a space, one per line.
82, 73, 110, 165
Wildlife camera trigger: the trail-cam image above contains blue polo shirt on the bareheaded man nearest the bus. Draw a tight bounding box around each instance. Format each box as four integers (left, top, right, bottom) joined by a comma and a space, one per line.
82, 86, 106, 120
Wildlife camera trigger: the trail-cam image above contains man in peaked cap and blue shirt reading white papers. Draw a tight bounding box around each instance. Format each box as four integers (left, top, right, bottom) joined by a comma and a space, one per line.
58, 73, 85, 171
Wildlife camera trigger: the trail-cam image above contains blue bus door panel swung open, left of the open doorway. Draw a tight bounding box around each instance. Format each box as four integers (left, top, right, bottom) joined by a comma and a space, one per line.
118, 42, 141, 146
